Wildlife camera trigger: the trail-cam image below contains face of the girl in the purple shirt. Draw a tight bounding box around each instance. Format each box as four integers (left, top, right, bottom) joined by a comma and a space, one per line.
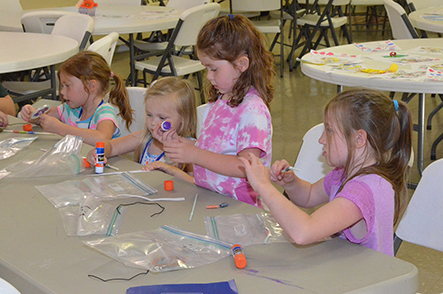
318, 120, 349, 167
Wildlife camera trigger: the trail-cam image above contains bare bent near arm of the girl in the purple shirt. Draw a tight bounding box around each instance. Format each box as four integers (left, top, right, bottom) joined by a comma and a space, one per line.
241, 156, 362, 244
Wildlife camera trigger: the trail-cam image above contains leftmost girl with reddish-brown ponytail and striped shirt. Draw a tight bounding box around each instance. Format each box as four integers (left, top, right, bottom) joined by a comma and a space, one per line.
21, 51, 133, 145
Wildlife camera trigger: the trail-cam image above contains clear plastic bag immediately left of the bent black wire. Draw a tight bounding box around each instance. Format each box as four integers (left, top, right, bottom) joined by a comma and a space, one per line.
59, 196, 126, 236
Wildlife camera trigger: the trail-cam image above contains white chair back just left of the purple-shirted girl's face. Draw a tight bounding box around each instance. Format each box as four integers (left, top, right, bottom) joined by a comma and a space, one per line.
294, 123, 332, 183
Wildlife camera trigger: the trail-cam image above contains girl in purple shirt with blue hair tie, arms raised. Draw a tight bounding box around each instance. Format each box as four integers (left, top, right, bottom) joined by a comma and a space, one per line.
241, 88, 412, 256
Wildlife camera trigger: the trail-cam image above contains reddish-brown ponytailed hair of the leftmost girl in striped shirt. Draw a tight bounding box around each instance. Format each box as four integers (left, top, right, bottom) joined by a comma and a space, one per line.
57, 51, 134, 129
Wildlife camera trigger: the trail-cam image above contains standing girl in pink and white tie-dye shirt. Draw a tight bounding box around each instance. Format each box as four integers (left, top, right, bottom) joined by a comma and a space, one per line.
147, 15, 274, 207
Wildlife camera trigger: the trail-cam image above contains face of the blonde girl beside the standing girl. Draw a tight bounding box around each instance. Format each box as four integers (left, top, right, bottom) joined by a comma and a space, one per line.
145, 94, 183, 134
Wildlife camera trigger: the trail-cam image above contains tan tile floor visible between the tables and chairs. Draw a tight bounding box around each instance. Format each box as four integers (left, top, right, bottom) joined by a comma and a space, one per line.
108, 21, 443, 294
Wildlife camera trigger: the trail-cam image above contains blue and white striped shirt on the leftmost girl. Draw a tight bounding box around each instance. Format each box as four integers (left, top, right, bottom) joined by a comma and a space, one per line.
57, 103, 120, 139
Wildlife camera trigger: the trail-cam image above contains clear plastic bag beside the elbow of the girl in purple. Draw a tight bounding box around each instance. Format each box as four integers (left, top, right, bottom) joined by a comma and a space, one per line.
205, 212, 291, 246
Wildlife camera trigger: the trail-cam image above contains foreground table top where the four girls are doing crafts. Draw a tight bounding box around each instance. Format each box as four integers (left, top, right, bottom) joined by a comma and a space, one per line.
0, 118, 418, 294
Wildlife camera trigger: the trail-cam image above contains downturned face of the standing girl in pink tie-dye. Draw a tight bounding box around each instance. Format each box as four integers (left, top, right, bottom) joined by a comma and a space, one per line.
197, 52, 242, 99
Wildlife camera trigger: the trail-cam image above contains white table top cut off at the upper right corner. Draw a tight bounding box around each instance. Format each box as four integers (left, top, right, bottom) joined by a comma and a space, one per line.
409, 6, 443, 33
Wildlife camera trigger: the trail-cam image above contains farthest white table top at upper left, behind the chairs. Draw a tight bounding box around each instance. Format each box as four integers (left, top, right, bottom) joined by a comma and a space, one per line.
0, 4, 181, 35
